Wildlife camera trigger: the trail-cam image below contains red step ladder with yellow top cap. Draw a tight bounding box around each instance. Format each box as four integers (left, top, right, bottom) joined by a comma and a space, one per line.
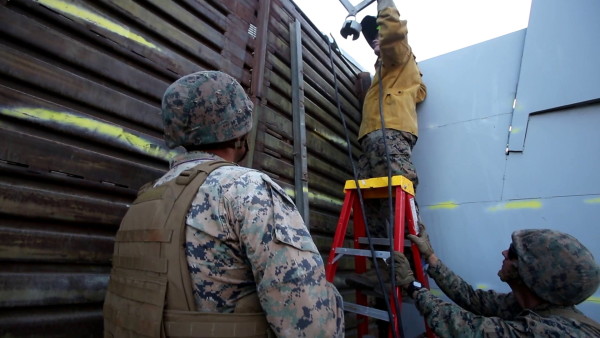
325, 175, 435, 338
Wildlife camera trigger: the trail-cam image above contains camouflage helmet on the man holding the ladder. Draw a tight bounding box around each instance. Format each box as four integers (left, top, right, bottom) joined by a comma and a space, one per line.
512, 229, 600, 306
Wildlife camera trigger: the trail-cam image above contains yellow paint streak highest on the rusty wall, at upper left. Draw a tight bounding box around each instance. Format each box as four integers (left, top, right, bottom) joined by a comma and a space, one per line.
37, 0, 160, 49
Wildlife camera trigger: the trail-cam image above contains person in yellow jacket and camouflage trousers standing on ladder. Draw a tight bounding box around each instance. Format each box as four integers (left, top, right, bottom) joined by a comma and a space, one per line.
346, 0, 427, 332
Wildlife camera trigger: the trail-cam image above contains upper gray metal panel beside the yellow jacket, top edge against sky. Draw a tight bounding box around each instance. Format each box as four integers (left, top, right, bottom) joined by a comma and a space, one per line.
418, 30, 525, 128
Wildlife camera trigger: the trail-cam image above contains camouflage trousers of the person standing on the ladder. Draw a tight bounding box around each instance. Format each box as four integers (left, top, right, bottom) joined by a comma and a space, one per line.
358, 129, 419, 237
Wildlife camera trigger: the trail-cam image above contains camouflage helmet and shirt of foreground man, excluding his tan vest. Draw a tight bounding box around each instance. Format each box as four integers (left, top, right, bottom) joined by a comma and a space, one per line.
156, 71, 344, 337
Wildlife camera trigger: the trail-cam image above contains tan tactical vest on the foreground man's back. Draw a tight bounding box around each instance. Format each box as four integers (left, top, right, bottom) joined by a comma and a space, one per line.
103, 161, 272, 337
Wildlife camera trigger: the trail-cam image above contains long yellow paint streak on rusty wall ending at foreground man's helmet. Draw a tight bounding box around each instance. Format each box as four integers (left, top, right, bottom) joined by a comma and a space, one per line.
0, 107, 178, 160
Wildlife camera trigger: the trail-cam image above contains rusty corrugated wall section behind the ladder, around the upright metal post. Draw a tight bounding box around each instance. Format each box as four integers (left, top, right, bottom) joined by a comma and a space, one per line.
252, 0, 370, 337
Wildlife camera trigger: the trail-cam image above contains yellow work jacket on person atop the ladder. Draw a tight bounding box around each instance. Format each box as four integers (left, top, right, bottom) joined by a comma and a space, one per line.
358, 7, 427, 139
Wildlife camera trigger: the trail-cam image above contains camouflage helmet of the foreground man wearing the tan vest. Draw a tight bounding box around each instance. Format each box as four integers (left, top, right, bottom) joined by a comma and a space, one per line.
162, 71, 253, 148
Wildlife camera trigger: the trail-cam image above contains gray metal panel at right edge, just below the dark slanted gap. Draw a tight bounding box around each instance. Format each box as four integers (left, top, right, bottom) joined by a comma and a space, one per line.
504, 104, 600, 198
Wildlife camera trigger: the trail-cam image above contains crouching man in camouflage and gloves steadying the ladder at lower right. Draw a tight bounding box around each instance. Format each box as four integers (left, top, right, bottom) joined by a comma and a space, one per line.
394, 229, 600, 337
